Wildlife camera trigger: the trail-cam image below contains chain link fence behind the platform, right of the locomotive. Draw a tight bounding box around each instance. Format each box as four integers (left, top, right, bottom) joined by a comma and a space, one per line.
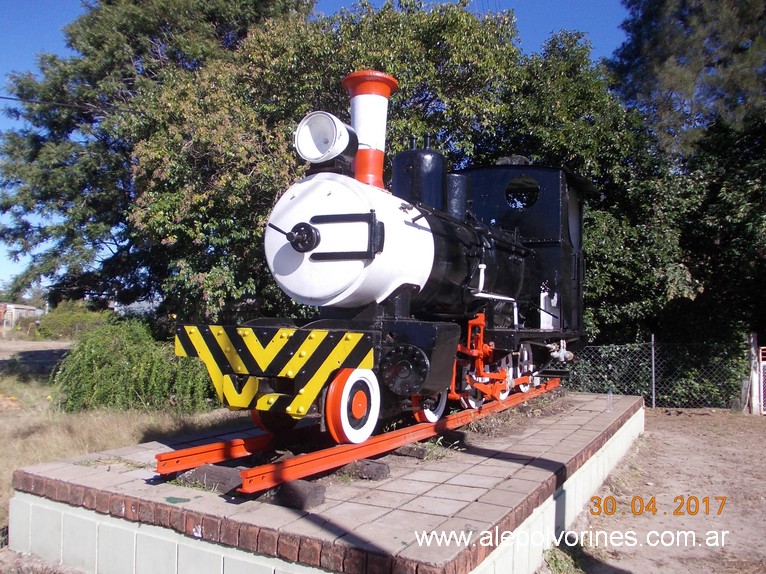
565, 340, 748, 408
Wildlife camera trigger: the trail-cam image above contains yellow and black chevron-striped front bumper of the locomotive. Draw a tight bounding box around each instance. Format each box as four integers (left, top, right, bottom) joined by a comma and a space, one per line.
176, 325, 376, 418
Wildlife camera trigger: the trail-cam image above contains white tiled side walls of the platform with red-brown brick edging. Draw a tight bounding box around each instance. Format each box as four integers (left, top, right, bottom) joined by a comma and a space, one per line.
9, 398, 644, 574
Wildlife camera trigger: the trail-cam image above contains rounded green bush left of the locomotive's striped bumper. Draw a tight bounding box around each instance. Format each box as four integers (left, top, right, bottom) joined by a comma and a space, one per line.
53, 319, 213, 412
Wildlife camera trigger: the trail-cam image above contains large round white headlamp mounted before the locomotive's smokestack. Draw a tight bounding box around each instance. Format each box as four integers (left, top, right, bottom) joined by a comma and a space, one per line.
295, 112, 358, 163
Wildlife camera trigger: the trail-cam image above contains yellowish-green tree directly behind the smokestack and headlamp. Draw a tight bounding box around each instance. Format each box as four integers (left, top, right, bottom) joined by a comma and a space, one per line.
132, 3, 536, 317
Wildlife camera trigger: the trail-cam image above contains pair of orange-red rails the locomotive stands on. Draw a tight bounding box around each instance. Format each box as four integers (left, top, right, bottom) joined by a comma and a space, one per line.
155, 379, 560, 494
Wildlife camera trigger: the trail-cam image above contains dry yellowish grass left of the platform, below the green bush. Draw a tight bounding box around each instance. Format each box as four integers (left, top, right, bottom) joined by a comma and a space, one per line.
0, 376, 247, 547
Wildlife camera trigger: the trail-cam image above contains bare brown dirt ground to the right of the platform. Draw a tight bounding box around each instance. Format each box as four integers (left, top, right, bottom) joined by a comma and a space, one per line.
562, 409, 766, 574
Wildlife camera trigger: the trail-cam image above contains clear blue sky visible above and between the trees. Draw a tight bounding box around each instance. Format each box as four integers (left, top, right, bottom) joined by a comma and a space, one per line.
0, 0, 627, 285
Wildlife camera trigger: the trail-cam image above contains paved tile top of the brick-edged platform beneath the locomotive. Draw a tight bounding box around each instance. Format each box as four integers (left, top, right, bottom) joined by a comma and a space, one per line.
13, 394, 643, 574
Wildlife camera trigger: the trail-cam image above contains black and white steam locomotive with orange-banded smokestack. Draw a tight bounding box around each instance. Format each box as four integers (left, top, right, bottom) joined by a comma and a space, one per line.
176, 70, 590, 443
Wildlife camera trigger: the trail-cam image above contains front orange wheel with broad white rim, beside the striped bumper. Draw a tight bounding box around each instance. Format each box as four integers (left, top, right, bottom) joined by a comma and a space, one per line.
325, 369, 380, 444
